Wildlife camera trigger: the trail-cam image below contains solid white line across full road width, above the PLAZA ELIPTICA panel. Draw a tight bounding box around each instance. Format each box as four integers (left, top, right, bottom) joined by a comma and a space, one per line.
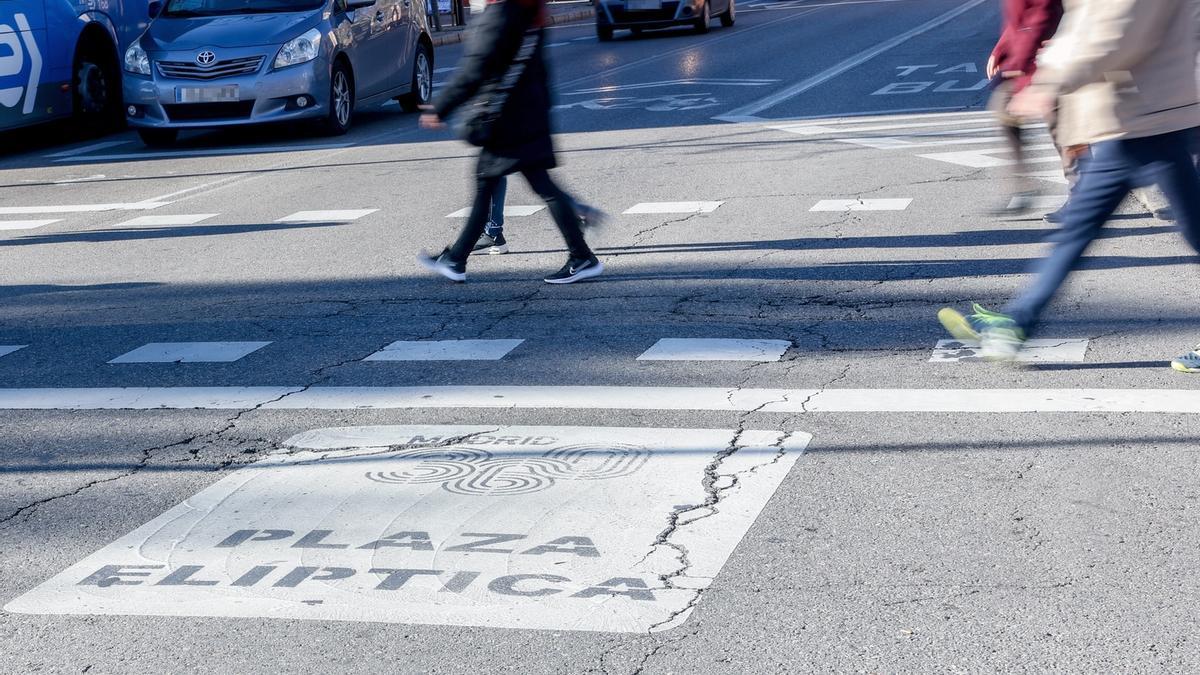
0, 386, 1200, 414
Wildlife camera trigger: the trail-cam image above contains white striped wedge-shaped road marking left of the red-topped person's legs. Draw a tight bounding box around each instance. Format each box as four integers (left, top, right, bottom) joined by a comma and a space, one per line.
766, 110, 1067, 185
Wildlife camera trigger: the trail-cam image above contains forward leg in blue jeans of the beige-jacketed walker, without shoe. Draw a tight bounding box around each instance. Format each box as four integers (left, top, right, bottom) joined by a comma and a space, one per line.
1004, 141, 1138, 334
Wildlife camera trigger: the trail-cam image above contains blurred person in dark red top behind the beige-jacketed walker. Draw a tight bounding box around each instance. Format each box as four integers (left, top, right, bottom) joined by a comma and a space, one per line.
988, 0, 1063, 215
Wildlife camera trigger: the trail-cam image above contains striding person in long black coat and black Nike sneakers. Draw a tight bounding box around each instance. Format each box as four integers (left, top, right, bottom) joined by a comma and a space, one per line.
418, 0, 604, 283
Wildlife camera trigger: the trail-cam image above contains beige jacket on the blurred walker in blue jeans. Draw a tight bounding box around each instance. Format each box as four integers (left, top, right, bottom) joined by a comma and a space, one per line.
1033, 0, 1200, 145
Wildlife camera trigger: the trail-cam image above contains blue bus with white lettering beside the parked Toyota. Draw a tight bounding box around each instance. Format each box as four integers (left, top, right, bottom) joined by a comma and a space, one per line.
0, 0, 150, 130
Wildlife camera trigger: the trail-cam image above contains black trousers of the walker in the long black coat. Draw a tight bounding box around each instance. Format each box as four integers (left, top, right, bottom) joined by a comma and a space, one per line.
450, 168, 593, 262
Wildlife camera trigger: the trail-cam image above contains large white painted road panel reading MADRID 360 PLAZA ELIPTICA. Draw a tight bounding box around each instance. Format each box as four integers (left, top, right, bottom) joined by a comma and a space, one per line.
4, 426, 811, 633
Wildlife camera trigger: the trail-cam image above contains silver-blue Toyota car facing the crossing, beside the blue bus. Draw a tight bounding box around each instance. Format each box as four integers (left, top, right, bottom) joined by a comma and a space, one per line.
124, 0, 433, 145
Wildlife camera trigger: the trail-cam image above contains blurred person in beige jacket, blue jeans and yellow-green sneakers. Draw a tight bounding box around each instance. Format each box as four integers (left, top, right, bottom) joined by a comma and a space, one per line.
938, 0, 1200, 371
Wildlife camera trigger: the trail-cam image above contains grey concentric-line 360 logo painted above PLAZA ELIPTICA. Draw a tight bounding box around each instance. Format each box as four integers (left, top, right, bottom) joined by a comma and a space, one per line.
366, 444, 649, 496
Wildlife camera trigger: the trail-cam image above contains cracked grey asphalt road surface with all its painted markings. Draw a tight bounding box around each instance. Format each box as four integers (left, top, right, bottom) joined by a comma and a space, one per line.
0, 0, 1200, 673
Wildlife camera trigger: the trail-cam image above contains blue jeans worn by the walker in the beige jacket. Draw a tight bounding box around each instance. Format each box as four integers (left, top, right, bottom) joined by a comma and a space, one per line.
1004, 129, 1200, 334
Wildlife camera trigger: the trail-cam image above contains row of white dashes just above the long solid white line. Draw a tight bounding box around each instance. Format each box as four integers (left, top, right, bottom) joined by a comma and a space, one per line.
0, 338, 1090, 366
